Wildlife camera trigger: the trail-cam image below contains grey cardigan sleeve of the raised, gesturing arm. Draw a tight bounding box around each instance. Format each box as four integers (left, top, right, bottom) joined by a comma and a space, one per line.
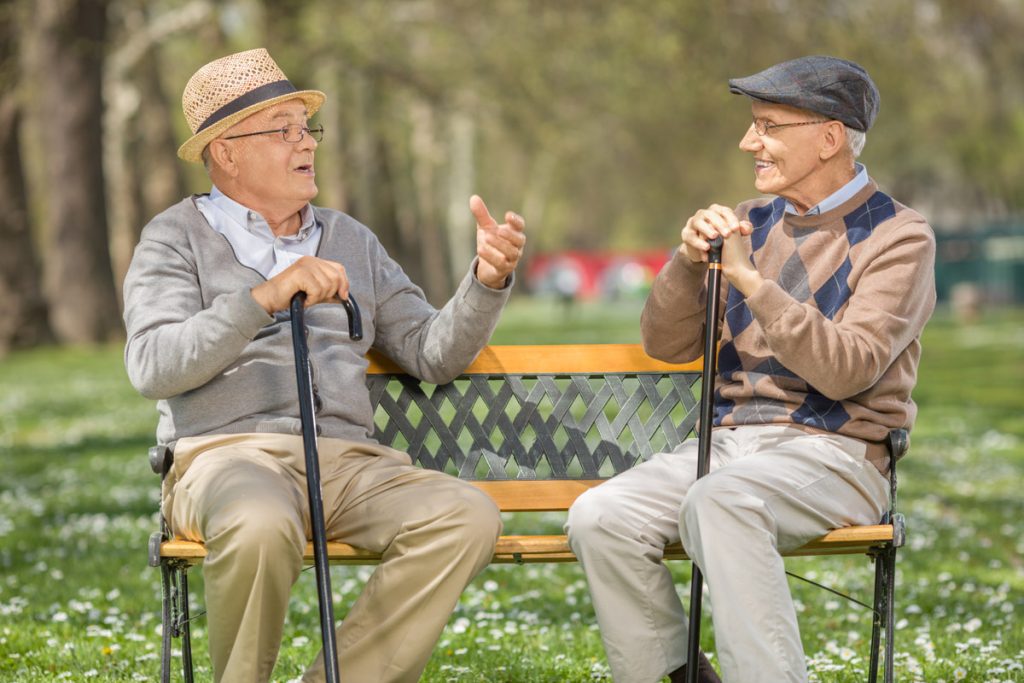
374, 245, 512, 384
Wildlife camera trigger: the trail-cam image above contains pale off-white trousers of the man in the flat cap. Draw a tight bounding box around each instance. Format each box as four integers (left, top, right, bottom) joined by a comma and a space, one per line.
566, 426, 889, 683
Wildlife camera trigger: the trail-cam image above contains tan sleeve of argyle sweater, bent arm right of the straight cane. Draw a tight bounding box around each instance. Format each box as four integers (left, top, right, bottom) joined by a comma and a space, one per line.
746, 216, 935, 400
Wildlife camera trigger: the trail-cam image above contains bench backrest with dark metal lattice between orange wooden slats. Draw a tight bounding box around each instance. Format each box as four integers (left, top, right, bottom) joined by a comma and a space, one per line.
368, 344, 701, 511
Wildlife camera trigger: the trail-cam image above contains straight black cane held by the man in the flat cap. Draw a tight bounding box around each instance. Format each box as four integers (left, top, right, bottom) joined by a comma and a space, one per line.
686, 237, 722, 683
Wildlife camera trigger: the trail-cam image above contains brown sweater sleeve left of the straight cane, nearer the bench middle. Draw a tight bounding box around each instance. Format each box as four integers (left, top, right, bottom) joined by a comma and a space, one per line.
640, 246, 728, 362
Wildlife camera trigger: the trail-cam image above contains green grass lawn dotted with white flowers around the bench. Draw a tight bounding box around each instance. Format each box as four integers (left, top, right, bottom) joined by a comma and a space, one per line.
0, 300, 1024, 683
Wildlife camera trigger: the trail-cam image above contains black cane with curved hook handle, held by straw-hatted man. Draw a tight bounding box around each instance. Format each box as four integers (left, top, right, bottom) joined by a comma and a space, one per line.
292, 292, 362, 683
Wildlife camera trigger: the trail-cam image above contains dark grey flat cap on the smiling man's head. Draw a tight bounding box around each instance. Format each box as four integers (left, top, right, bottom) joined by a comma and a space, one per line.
729, 55, 880, 131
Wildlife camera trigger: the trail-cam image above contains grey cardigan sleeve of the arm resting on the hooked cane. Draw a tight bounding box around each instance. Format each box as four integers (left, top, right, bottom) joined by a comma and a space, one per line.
124, 229, 273, 399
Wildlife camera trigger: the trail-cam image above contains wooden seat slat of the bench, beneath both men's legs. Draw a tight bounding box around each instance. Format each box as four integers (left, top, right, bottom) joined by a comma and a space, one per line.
160, 524, 893, 564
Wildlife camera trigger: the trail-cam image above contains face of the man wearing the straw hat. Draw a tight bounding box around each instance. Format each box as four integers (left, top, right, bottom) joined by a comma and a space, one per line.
227, 99, 317, 208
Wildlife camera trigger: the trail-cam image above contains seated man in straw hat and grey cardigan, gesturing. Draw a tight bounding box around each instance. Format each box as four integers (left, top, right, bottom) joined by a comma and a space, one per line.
124, 49, 525, 683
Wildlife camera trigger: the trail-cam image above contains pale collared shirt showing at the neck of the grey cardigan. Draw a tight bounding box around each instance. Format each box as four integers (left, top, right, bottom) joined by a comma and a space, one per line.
196, 185, 323, 280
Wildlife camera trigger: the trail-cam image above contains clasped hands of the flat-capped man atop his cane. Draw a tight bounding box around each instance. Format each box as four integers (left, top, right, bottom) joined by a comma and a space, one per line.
679, 204, 763, 296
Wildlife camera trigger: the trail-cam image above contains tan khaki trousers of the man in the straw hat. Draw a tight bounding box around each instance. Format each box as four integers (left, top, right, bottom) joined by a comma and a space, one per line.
164, 434, 501, 683
